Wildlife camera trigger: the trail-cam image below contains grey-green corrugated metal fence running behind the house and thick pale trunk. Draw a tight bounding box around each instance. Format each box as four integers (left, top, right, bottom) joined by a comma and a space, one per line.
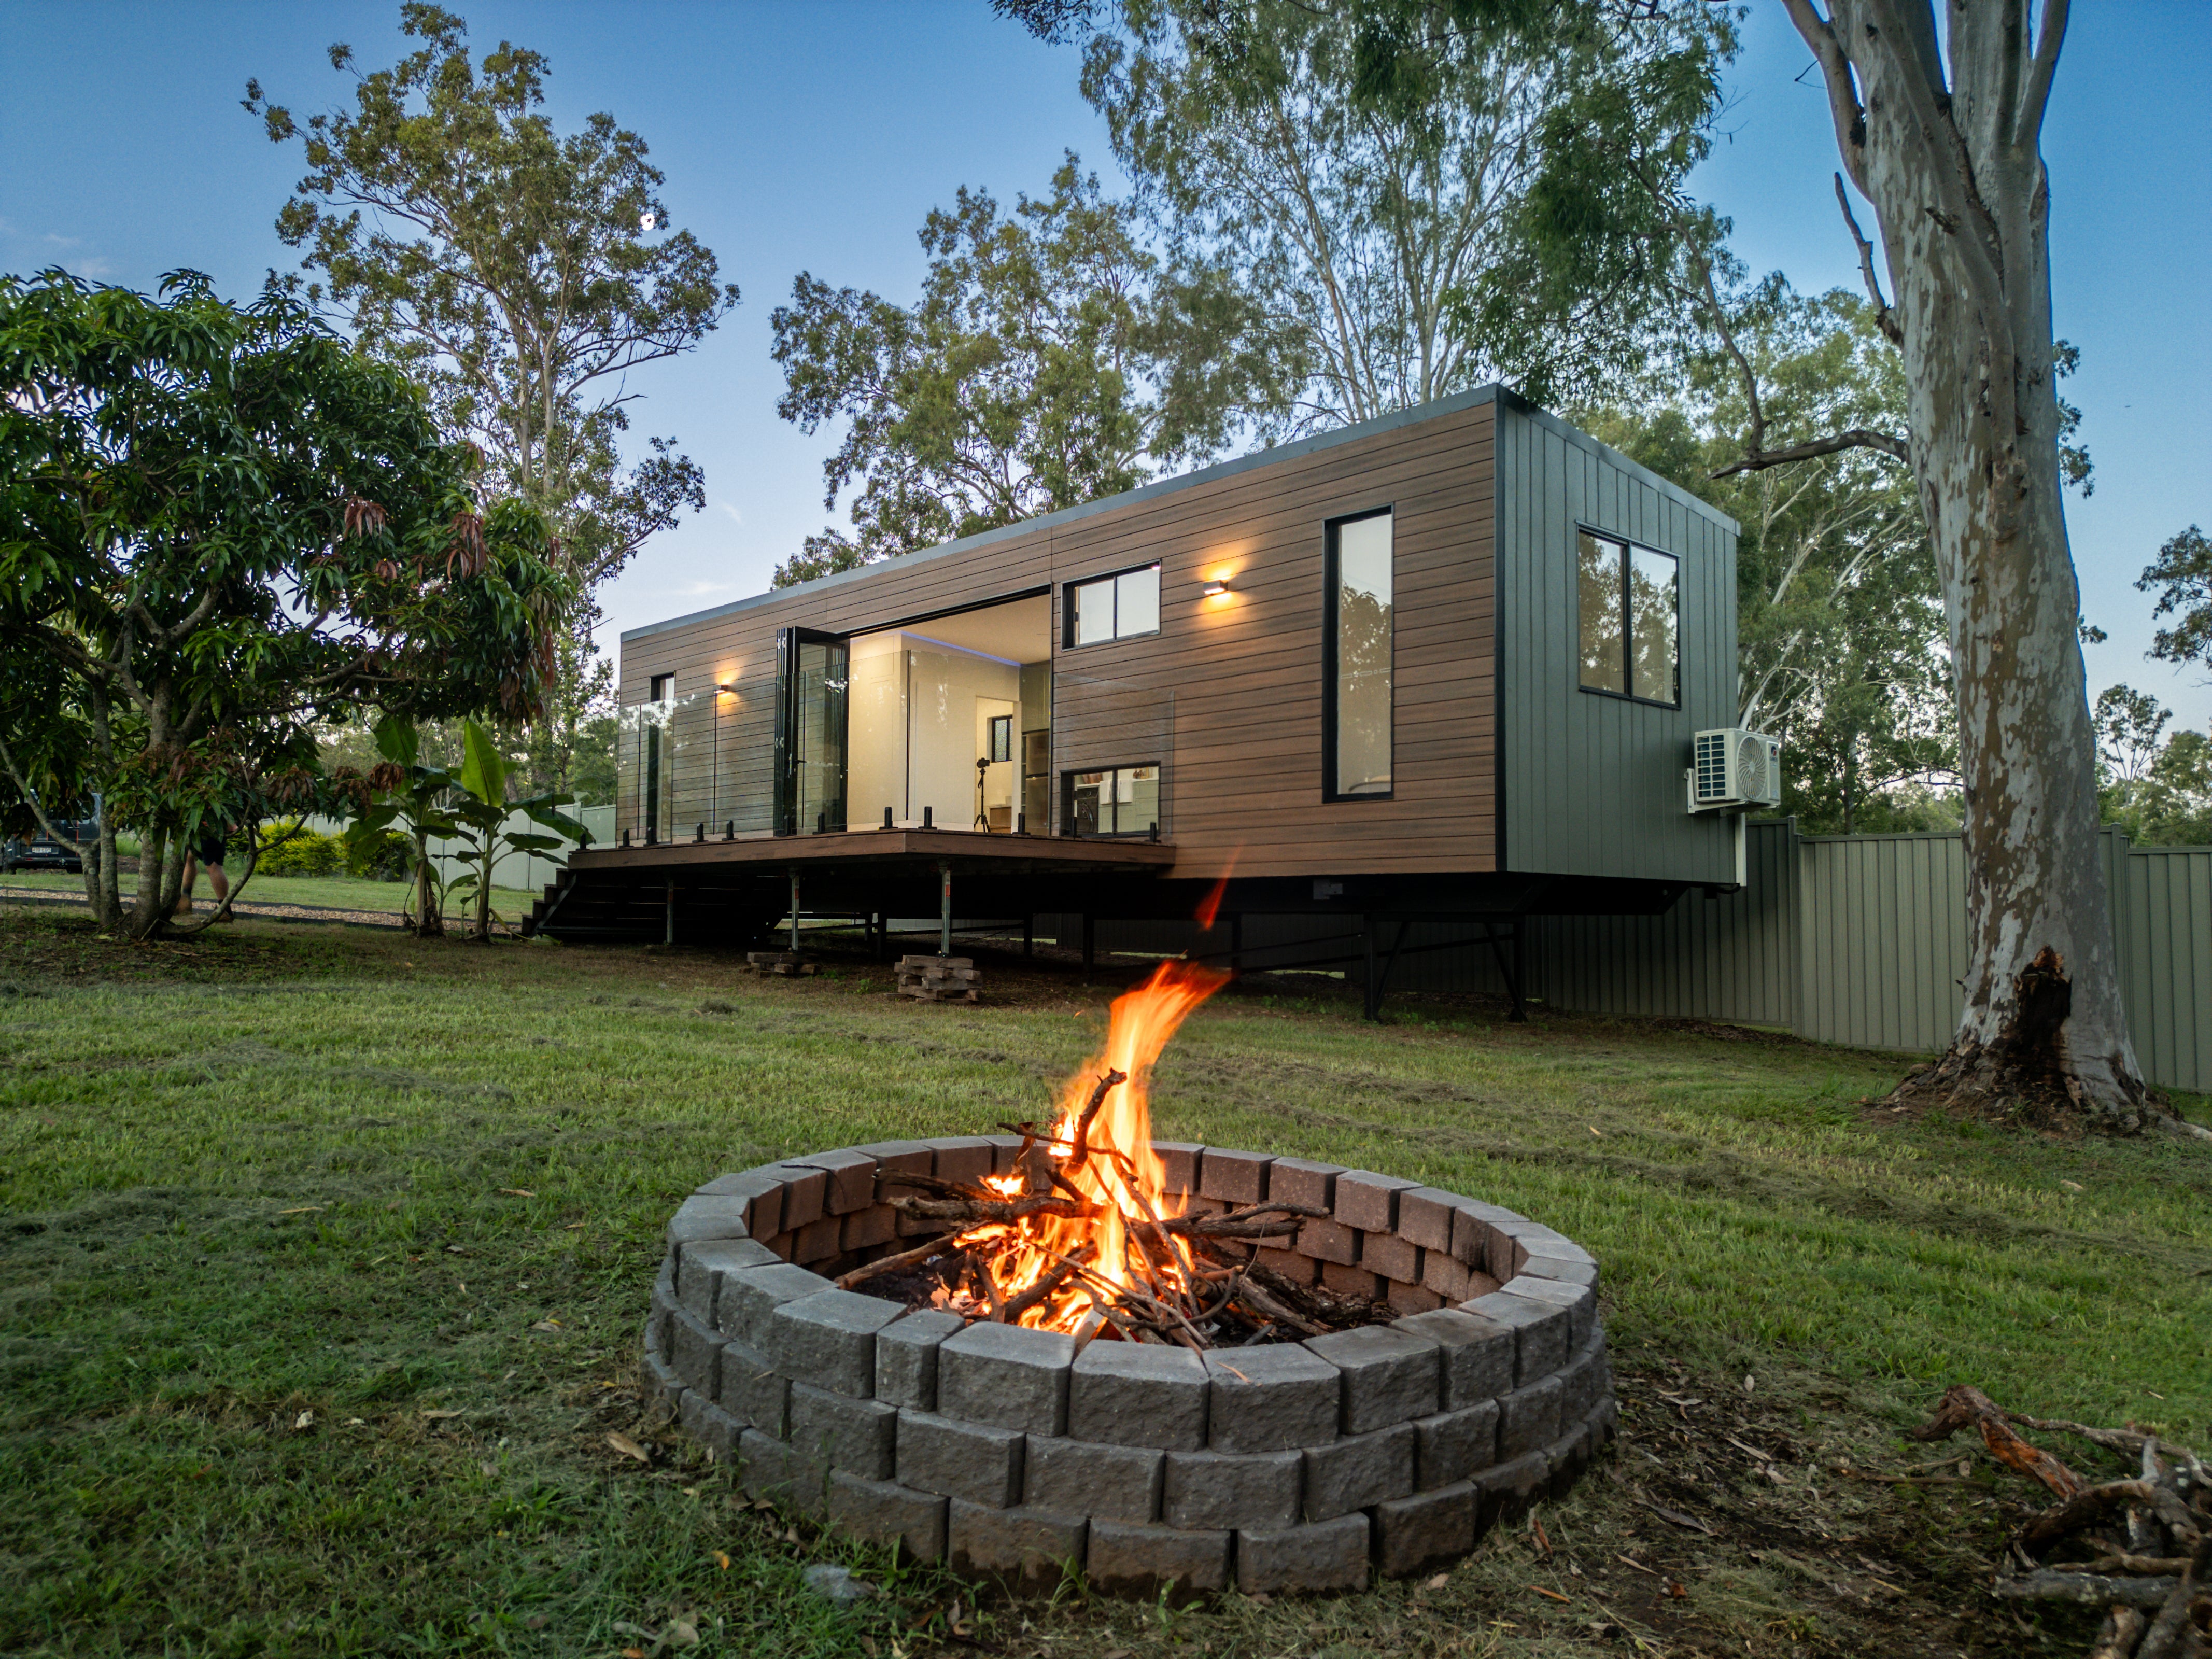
1039, 823, 2212, 1093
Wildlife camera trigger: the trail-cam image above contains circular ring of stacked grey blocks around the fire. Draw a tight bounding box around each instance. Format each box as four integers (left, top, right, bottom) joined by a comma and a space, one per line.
641, 1135, 1617, 1599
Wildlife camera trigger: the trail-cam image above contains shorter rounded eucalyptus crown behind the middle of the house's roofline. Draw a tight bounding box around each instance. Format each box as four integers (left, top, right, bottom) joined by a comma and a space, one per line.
772, 155, 1294, 586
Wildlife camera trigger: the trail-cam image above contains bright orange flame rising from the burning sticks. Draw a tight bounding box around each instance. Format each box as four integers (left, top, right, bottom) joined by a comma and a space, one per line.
969, 962, 1230, 1329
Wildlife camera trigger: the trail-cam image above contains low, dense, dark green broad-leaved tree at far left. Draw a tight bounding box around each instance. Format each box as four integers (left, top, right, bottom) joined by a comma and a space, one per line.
0, 272, 571, 938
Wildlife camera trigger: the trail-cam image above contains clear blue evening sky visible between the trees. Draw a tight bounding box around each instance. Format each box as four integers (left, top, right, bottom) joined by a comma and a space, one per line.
0, 0, 2212, 725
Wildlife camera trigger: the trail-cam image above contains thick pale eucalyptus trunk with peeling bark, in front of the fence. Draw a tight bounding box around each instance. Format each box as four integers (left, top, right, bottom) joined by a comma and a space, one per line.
1785, 0, 2148, 1130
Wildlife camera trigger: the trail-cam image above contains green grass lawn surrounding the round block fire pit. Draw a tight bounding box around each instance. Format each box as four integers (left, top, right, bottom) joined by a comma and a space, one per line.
0, 911, 2212, 1659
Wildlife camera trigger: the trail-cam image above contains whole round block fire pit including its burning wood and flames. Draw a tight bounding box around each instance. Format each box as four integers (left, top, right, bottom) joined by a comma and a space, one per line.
644, 964, 1615, 1599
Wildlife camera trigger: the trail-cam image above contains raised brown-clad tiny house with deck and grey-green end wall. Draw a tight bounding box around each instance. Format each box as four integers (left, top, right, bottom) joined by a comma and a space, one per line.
531, 387, 1779, 1022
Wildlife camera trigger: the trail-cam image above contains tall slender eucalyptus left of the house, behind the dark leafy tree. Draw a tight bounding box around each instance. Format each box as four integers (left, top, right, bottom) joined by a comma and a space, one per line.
246, 0, 739, 752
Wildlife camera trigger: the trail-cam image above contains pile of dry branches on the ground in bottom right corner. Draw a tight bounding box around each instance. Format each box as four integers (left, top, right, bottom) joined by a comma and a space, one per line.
1913, 1385, 2212, 1659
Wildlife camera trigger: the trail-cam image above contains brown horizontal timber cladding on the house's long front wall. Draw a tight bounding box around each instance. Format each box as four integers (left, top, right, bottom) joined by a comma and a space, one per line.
622, 403, 1495, 876
